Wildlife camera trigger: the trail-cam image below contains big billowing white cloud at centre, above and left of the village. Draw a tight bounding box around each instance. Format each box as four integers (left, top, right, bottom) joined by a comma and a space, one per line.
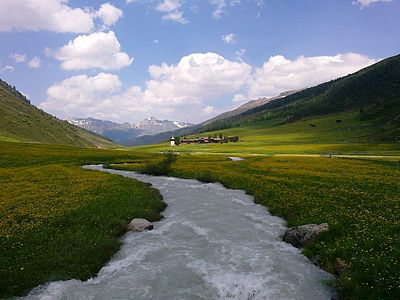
147, 52, 252, 103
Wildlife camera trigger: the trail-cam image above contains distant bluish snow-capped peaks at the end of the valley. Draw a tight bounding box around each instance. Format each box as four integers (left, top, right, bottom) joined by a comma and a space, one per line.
67, 117, 193, 144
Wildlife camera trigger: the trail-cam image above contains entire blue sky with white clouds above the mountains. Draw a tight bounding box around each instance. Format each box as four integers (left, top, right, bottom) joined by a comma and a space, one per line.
0, 0, 400, 123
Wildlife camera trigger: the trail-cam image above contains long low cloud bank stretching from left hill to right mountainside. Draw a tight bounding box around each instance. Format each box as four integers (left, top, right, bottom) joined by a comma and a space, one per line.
41, 53, 375, 122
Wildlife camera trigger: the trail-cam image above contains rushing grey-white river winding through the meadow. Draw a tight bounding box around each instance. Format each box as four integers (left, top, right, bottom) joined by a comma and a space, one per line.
26, 166, 332, 300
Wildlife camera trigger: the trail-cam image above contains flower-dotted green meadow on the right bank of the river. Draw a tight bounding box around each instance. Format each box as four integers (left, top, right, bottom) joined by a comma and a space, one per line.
114, 155, 400, 299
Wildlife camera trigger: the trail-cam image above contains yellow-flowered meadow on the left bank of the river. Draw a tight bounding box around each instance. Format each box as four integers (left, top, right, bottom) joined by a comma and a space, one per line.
0, 142, 164, 298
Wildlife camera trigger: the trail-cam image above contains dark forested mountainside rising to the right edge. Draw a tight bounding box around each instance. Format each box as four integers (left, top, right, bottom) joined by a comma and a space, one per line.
200, 55, 400, 142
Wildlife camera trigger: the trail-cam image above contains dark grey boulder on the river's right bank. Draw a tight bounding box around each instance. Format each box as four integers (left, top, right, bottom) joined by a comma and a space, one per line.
283, 223, 329, 248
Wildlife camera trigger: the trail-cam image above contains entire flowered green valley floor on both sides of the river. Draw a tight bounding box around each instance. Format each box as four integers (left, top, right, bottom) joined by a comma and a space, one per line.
0, 142, 400, 299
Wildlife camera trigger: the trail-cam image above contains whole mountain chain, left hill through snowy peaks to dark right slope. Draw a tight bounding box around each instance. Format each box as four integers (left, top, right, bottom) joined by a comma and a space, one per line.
0, 55, 400, 148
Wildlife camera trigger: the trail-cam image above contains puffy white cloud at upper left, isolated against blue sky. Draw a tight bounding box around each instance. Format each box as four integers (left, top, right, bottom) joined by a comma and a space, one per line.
54, 31, 133, 70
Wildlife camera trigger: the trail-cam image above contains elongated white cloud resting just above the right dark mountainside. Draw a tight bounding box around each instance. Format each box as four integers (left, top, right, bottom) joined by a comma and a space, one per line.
248, 53, 376, 99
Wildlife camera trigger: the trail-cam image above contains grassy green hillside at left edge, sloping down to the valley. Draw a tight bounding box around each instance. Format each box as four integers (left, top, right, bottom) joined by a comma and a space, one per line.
0, 80, 117, 148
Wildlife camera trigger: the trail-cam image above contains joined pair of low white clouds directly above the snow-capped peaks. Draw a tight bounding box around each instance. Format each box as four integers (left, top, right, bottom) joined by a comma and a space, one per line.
41, 53, 251, 121
